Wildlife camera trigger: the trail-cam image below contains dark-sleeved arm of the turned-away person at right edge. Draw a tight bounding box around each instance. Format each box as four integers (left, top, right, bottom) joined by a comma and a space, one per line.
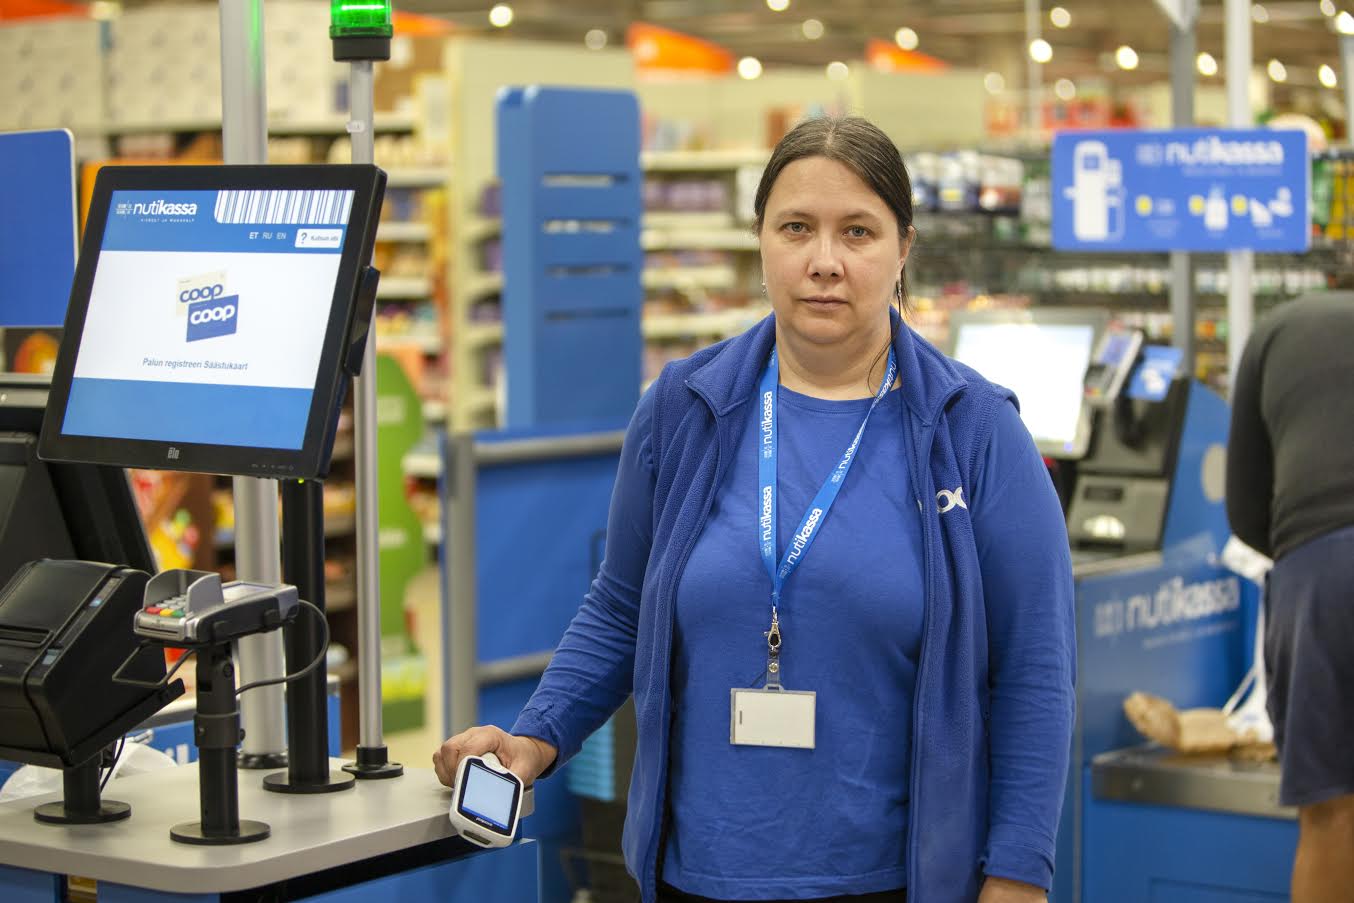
1227, 320, 1274, 556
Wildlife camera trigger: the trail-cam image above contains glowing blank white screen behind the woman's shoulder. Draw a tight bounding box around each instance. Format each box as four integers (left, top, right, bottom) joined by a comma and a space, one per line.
952, 311, 1105, 459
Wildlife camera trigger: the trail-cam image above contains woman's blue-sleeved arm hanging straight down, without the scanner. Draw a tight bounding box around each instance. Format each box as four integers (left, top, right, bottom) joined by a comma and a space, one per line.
972, 405, 1076, 903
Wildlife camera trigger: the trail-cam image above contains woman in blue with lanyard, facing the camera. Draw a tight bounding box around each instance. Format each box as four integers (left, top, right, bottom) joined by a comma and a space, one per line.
433, 118, 1074, 903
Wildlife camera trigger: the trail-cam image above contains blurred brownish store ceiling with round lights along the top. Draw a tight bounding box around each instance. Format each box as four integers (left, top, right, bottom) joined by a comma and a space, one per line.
387, 0, 1354, 81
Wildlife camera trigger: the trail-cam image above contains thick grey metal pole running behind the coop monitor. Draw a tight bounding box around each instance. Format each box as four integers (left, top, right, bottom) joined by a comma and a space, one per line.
221, 0, 287, 769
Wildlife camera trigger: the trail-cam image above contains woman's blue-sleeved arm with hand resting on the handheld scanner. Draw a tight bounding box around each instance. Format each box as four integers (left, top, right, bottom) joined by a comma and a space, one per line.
433, 393, 654, 787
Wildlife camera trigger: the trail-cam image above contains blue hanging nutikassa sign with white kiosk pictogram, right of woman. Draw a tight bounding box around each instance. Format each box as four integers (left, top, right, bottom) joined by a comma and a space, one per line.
1052, 129, 1312, 252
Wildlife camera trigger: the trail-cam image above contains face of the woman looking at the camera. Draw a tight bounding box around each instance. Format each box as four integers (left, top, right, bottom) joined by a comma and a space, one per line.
760, 157, 911, 345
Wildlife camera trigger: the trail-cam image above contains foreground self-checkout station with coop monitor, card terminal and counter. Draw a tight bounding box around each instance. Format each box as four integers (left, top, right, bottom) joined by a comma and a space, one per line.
0, 157, 539, 903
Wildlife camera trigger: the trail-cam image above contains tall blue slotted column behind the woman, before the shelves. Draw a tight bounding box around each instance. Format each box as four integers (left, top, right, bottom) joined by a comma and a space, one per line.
497, 87, 645, 429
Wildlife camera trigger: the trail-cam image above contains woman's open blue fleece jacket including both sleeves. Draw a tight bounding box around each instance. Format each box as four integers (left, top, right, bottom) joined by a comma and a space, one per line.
513, 317, 1075, 903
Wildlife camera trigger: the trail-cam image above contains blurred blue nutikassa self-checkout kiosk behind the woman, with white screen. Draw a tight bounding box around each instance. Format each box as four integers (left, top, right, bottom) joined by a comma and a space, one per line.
952, 309, 1272, 903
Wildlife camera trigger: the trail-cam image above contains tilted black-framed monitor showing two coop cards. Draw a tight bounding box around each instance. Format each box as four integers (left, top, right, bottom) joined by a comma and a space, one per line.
42, 167, 385, 478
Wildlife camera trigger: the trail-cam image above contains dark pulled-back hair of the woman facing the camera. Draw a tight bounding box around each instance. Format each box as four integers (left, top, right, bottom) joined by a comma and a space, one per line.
753, 116, 913, 313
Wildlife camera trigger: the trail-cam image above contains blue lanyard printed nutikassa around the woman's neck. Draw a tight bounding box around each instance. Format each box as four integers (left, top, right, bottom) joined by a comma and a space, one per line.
757, 348, 898, 628
